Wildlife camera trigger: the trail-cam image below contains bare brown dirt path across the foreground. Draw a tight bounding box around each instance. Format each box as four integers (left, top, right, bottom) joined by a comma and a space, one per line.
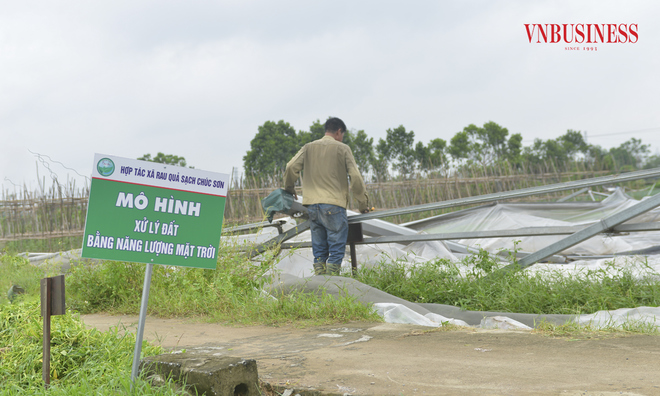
82, 315, 660, 396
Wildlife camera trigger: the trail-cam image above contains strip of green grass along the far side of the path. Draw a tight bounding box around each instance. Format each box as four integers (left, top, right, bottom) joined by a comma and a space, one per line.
5, 246, 660, 325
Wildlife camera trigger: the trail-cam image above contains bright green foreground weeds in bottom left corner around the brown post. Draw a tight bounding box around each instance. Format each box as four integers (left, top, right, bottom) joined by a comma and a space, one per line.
0, 296, 183, 396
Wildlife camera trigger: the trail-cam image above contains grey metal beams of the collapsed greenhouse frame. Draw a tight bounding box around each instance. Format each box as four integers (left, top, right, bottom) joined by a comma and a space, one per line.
231, 168, 660, 271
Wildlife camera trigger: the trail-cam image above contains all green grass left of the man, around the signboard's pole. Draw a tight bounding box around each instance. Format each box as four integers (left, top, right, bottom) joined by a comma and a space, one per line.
0, 247, 382, 395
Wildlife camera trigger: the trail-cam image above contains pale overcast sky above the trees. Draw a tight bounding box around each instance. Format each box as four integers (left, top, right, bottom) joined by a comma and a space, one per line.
0, 0, 660, 192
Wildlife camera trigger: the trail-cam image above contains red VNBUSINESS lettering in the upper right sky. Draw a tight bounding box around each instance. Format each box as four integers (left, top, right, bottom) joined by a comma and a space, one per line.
525, 23, 639, 49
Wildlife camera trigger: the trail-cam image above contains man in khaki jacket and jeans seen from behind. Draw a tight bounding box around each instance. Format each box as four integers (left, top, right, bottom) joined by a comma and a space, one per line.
284, 118, 369, 275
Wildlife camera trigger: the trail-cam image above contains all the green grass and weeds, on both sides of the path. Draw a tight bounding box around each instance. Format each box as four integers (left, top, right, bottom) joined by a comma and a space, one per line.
0, 246, 660, 395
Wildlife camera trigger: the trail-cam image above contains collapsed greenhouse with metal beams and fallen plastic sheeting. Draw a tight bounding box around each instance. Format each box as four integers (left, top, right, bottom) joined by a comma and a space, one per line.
227, 169, 660, 329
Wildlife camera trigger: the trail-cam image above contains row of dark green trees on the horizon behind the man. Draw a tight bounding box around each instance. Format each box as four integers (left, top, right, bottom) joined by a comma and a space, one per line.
243, 120, 660, 181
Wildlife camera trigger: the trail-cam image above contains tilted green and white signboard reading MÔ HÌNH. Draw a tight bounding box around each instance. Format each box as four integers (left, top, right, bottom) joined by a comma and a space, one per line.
82, 154, 229, 269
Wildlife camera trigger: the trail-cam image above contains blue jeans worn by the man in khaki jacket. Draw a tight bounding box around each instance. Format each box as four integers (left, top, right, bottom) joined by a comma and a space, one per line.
307, 204, 348, 265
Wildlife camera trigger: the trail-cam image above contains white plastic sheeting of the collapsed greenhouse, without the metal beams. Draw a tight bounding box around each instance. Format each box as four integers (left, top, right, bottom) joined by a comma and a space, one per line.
237, 190, 660, 329
